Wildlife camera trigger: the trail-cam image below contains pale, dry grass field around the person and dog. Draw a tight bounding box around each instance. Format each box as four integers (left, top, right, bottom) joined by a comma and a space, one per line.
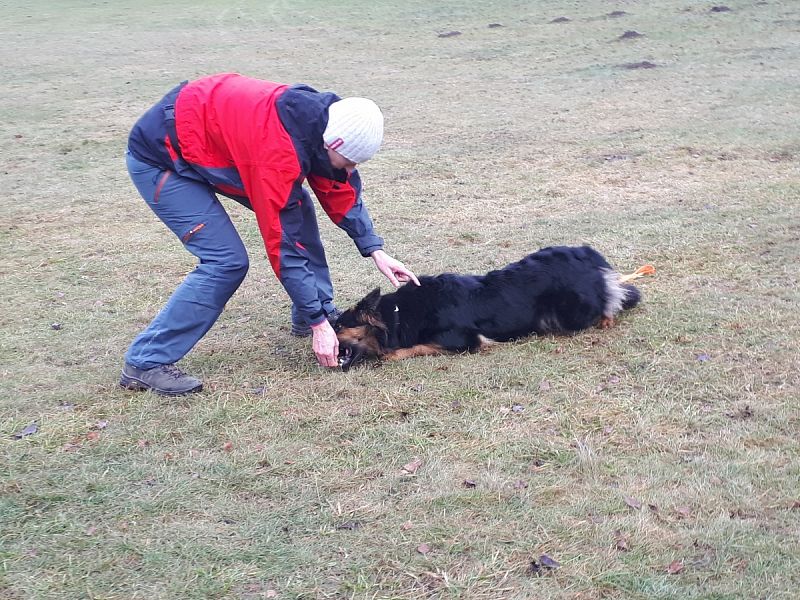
0, 0, 800, 600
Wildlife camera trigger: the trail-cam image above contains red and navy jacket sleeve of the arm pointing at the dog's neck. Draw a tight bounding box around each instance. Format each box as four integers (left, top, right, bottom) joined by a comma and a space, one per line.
308, 171, 383, 256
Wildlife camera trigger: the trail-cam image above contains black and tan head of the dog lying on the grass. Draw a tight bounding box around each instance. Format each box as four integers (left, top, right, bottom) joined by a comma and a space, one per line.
333, 288, 388, 371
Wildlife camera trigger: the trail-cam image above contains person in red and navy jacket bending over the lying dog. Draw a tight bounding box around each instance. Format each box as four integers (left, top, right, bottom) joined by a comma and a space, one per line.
120, 73, 419, 395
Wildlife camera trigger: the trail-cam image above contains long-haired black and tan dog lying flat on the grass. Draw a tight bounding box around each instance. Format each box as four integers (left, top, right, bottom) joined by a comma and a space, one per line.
334, 246, 641, 370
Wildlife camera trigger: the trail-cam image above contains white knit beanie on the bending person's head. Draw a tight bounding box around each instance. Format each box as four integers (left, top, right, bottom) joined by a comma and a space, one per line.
322, 98, 383, 163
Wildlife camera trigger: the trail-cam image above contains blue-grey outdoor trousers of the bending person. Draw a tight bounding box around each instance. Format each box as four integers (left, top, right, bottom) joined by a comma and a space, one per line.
125, 152, 333, 369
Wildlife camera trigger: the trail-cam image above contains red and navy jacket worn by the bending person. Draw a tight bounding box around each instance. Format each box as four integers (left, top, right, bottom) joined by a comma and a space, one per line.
128, 73, 383, 324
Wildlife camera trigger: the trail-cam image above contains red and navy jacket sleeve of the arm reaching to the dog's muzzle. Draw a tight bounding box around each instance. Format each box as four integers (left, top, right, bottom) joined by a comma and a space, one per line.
240, 165, 325, 325
